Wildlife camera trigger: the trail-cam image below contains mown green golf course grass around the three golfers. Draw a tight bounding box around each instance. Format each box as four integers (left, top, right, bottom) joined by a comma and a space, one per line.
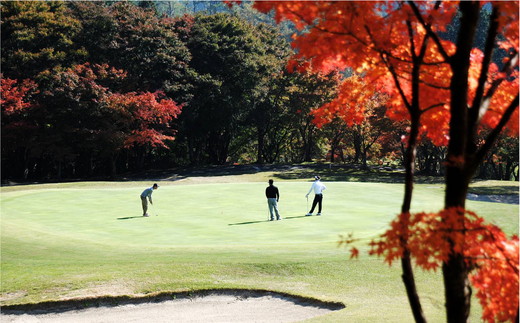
1, 173, 519, 322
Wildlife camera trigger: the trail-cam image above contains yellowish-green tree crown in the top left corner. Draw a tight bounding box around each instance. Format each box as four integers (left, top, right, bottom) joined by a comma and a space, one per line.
1, 1, 82, 79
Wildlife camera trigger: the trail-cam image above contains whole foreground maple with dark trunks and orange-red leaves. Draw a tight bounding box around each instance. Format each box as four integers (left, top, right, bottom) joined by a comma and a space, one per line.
250, 1, 518, 322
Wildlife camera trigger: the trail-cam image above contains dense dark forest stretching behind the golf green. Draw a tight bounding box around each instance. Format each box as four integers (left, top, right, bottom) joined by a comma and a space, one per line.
1, 1, 519, 182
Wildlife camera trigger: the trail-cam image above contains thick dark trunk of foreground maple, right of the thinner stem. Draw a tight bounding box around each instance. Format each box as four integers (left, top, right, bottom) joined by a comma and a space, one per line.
442, 1, 480, 323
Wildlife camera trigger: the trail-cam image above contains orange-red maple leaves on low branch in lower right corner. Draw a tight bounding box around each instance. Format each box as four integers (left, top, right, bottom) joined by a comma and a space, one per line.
369, 208, 519, 322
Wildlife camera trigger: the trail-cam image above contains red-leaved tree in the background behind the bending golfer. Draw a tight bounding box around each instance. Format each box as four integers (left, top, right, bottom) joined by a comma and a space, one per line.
33, 63, 181, 175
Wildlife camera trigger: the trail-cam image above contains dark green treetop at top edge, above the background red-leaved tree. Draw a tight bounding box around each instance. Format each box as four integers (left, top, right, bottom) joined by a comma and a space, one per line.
70, 1, 191, 98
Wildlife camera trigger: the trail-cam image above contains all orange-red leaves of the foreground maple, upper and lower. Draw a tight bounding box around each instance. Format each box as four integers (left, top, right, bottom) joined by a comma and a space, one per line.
250, 1, 519, 322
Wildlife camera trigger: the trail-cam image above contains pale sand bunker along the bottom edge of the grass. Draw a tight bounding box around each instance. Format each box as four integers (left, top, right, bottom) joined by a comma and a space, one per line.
0, 291, 344, 323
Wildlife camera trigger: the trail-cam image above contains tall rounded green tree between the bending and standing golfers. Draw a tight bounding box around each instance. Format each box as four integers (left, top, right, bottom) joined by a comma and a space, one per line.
176, 14, 288, 164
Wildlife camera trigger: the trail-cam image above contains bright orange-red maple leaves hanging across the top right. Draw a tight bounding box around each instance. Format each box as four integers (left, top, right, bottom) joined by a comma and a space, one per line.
255, 1, 518, 145
